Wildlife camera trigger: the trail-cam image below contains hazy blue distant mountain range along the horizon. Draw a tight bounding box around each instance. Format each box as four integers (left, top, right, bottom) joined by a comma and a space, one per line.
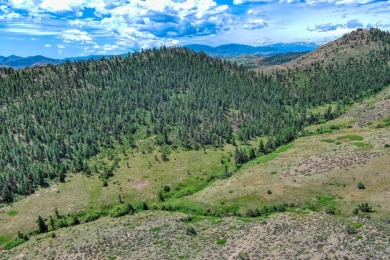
0, 42, 319, 69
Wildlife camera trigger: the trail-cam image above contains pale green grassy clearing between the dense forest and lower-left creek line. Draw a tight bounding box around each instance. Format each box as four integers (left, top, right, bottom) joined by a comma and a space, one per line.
0, 146, 234, 244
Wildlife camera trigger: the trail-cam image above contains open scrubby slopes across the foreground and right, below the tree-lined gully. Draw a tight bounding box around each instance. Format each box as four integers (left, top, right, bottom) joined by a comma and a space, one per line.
3, 87, 390, 259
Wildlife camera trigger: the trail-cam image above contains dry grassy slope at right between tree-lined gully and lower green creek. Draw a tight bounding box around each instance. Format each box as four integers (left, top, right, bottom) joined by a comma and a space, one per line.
183, 88, 390, 217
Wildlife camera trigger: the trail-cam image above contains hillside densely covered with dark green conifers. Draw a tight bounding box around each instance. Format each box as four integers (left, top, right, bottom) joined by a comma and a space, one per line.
0, 31, 390, 202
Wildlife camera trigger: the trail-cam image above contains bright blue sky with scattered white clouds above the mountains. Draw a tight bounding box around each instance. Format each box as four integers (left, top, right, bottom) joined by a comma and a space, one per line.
0, 0, 390, 58
